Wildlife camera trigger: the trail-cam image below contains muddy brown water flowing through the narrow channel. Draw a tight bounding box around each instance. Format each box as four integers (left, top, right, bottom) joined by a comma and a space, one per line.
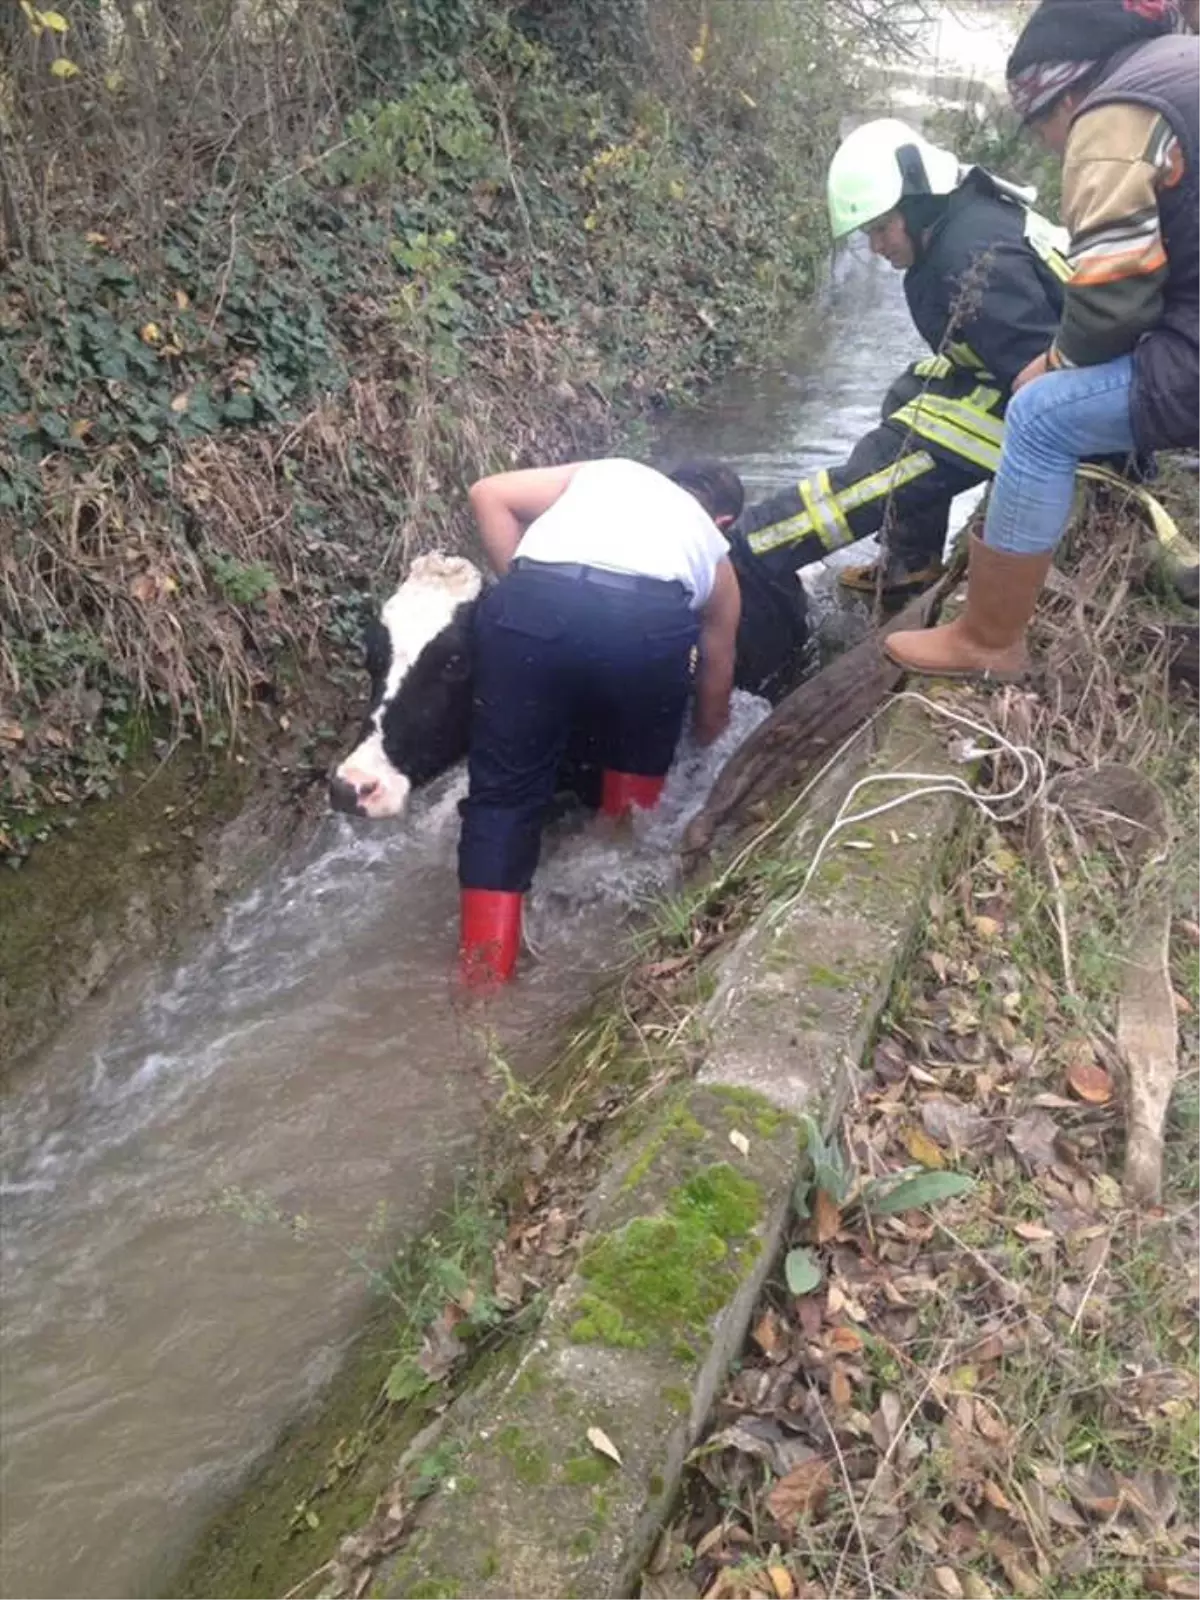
0, 6, 1017, 1600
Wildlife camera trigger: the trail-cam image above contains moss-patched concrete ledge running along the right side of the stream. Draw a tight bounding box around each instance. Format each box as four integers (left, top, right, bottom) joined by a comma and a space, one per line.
370, 704, 958, 1600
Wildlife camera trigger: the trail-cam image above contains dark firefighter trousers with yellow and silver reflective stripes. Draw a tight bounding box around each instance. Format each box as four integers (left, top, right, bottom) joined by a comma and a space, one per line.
738, 355, 1008, 574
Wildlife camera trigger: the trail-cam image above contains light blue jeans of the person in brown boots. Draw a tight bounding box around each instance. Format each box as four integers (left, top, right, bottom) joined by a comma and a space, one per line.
984, 355, 1136, 555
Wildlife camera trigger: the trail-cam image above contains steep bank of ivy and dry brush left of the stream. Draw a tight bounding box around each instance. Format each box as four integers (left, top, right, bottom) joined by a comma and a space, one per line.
0, 0, 869, 861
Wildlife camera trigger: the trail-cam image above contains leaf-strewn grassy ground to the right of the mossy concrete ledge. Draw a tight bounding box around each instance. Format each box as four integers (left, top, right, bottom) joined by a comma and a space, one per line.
642, 496, 1200, 1600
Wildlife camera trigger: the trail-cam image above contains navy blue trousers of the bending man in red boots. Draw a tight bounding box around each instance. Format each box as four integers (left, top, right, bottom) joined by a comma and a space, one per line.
458, 565, 699, 893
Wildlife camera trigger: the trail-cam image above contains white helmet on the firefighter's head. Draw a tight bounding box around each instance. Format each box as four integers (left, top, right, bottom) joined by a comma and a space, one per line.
827, 117, 965, 238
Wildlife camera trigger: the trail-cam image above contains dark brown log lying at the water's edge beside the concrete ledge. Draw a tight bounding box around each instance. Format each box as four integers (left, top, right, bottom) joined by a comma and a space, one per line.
682, 563, 963, 872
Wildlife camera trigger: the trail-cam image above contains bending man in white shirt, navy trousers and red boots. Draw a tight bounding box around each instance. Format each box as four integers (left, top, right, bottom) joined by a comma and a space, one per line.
459, 459, 742, 987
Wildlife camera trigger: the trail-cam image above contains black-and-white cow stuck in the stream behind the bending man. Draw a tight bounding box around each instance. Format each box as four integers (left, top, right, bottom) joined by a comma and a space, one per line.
330, 541, 806, 818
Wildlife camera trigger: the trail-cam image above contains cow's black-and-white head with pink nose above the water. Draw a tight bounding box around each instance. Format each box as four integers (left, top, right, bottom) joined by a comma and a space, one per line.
330, 554, 483, 818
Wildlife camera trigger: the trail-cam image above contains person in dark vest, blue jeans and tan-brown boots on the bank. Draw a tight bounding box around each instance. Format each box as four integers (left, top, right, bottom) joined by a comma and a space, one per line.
886, 0, 1200, 678
